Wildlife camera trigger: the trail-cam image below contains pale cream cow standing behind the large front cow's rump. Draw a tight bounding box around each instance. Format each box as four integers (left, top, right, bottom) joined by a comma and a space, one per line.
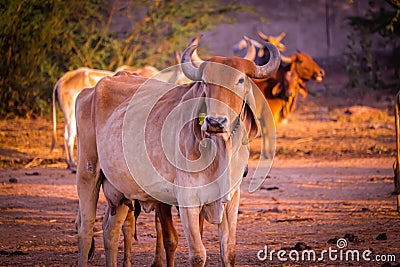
51, 65, 188, 171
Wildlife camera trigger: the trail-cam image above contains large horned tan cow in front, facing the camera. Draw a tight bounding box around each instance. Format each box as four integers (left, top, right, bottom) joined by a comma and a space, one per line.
76, 36, 280, 266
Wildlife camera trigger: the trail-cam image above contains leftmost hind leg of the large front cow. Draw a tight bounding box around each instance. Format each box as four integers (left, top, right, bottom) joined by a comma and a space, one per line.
76, 160, 101, 266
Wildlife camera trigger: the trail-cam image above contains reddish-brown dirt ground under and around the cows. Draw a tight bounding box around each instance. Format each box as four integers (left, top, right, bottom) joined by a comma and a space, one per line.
0, 85, 400, 266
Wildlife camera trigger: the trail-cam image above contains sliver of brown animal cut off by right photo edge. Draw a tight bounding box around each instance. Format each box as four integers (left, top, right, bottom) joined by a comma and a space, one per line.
393, 91, 400, 212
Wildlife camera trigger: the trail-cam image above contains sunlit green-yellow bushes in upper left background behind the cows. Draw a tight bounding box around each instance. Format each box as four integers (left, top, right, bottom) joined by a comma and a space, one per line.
0, 0, 255, 117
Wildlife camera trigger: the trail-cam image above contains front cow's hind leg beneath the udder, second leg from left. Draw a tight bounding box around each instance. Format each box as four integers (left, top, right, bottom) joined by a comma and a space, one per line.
103, 205, 132, 266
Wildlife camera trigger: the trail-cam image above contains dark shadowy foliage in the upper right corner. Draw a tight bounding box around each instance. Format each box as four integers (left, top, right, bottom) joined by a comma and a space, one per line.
344, 0, 400, 94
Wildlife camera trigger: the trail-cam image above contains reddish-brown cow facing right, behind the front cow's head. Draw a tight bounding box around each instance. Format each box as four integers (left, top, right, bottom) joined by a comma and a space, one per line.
238, 32, 325, 158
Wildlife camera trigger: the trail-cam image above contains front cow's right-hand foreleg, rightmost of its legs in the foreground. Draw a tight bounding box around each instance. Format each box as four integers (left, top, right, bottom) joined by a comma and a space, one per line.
218, 189, 240, 266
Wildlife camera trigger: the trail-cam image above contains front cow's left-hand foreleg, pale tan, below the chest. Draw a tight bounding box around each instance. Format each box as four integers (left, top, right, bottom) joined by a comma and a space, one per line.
179, 207, 207, 267
